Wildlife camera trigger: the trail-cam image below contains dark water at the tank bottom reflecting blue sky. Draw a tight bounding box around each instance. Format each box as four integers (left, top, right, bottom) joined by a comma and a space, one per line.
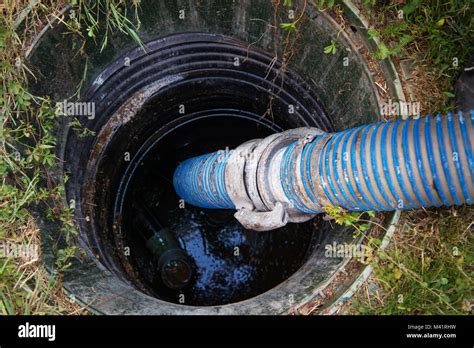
122, 117, 314, 306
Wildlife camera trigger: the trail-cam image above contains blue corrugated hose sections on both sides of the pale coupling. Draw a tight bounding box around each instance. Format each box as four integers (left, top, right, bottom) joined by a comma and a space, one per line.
173, 110, 474, 213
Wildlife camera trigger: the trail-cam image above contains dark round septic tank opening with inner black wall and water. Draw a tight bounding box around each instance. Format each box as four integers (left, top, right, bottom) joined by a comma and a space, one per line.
83, 34, 348, 306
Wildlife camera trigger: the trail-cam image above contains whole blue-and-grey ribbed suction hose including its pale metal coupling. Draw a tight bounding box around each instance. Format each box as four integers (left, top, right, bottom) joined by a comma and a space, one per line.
173, 110, 474, 230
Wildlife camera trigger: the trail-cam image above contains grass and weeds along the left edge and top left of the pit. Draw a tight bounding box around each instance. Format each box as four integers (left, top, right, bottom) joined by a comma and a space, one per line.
0, 0, 141, 315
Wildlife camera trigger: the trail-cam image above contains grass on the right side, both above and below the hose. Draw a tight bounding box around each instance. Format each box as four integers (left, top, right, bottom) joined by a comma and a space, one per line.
349, 0, 474, 315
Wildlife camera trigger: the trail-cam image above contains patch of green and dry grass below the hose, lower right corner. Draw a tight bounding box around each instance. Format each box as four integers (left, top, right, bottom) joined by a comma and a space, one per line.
353, 207, 474, 315
